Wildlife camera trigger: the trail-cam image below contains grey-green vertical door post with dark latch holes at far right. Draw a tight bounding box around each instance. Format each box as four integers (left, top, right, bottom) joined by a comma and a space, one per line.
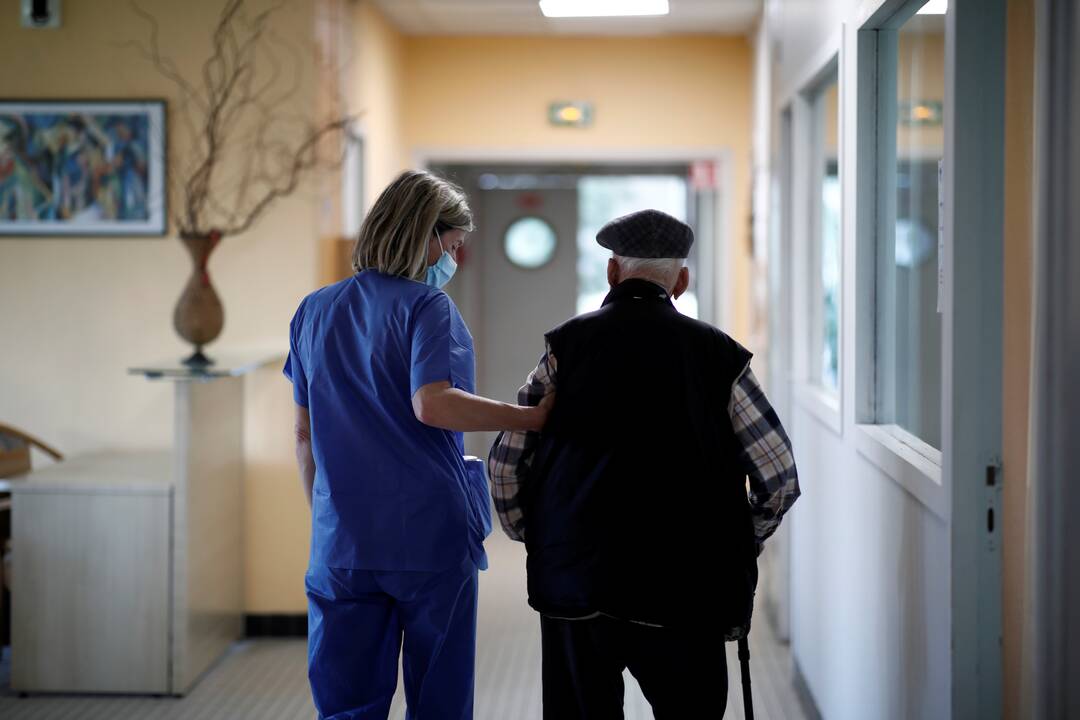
942, 0, 1005, 720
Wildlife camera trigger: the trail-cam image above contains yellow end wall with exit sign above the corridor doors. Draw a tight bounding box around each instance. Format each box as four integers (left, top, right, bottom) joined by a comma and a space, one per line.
403, 36, 753, 338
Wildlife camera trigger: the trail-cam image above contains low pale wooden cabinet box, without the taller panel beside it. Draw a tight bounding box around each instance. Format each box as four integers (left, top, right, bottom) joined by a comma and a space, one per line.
11, 452, 173, 693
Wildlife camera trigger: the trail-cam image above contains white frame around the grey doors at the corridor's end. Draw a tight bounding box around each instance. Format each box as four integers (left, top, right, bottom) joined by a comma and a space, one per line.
411, 146, 734, 330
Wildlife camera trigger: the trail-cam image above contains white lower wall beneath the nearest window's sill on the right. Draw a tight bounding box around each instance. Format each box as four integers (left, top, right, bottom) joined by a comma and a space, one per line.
789, 414, 949, 720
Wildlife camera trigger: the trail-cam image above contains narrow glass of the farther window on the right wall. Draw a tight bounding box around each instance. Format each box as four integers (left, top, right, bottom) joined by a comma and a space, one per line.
809, 70, 842, 393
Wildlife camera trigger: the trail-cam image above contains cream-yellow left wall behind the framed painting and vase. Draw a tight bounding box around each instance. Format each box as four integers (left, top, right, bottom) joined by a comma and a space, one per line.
0, 0, 318, 611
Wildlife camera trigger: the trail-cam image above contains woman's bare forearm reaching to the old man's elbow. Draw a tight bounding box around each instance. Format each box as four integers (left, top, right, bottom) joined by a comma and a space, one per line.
413, 381, 555, 433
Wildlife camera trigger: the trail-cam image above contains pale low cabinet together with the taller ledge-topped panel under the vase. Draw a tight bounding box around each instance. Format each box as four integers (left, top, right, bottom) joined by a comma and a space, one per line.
11, 363, 255, 695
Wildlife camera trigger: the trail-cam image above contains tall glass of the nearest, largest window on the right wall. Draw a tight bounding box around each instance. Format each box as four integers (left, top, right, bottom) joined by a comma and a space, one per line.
876, 2, 945, 448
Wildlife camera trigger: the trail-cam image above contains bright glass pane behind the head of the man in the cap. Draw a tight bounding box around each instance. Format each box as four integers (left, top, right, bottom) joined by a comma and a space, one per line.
578, 175, 698, 317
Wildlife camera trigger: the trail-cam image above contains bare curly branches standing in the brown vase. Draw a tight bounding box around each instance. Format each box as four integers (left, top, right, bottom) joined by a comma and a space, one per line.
132, 0, 352, 236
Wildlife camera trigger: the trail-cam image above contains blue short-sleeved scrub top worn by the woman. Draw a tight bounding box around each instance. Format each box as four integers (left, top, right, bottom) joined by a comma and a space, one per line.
284, 270, 490, 571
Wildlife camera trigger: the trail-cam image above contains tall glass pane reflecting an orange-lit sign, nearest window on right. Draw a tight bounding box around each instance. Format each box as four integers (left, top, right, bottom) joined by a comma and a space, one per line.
879, 3, 945, 448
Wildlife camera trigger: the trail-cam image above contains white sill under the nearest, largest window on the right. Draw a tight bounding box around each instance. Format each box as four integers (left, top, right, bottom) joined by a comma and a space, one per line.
854, 424, 948, 520
